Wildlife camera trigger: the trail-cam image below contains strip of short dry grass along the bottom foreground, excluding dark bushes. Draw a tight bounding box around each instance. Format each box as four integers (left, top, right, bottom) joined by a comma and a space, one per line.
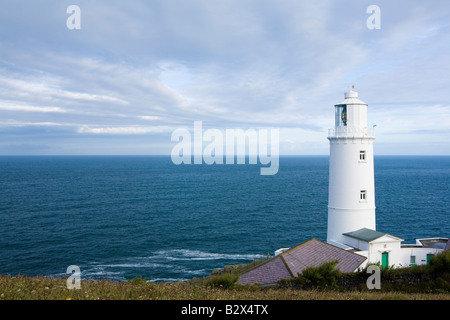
0, 276, 450, 300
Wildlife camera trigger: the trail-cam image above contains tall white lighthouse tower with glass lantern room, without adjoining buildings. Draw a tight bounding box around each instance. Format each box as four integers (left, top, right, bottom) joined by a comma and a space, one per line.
327, 90, 376, 245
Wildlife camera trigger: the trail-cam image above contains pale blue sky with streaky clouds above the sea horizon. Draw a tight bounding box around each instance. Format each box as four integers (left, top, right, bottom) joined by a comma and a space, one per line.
0, 0, 450, 155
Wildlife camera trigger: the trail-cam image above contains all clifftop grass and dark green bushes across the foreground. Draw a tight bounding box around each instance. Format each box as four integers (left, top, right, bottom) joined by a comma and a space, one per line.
0, 251, 450, 300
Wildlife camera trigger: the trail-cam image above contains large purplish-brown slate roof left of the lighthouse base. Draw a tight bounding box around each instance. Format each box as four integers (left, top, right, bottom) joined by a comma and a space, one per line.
238, 239, 366, 284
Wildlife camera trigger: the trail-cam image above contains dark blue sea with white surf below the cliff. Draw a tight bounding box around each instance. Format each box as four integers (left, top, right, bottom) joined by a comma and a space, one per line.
0, 156, 450, 282
